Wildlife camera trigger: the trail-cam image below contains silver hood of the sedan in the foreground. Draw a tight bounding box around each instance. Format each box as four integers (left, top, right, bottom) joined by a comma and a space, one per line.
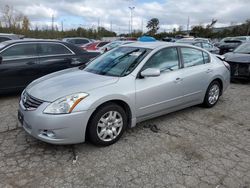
26, 68, 119, 102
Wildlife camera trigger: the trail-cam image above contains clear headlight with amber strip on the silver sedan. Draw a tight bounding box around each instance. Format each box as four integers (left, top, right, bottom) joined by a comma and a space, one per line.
43, 93, 88, 114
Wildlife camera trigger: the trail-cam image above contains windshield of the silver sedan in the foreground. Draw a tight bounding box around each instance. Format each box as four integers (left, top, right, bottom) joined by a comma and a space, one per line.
84, 46, 151, 77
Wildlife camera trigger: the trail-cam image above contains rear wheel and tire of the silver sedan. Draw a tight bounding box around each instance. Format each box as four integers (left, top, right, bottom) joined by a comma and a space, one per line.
203, 81, 221, 108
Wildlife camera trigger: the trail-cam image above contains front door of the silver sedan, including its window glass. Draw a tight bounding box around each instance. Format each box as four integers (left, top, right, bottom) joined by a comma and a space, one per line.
136, 48, 183, 118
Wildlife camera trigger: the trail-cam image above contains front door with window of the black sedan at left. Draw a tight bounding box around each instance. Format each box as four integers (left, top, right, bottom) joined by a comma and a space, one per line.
0, 43, 39, 90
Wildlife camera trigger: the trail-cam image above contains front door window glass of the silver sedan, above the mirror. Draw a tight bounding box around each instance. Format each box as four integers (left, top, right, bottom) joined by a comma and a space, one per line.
143, 48, 179, 72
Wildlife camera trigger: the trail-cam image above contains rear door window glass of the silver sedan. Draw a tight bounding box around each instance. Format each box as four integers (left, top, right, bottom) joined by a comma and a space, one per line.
181, 48, 204, 67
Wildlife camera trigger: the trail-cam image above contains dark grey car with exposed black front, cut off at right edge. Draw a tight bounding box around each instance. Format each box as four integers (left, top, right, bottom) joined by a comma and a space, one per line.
224, 43, 250, 79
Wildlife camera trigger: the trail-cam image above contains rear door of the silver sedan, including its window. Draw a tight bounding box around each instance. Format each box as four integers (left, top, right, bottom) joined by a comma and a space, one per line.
180, 47, 213, 103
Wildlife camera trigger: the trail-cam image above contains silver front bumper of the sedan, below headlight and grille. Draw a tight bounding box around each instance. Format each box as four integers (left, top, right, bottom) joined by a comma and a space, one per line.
18, 101, 92, 144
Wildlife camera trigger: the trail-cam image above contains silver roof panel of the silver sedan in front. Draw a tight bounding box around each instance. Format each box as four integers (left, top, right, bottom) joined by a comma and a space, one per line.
125, 41, 180, 50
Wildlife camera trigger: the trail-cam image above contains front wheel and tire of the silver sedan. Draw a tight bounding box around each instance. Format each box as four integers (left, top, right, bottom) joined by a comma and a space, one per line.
87, 103, 128, 146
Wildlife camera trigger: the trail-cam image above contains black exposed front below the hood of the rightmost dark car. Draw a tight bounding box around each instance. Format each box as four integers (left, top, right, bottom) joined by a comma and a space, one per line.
228, 62, 250, 76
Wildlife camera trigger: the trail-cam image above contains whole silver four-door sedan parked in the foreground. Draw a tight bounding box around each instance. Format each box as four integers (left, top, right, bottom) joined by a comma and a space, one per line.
18, 42, 230, 146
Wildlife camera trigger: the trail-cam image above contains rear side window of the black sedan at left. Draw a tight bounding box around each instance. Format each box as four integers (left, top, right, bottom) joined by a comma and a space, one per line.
38, 43, 72, 56
